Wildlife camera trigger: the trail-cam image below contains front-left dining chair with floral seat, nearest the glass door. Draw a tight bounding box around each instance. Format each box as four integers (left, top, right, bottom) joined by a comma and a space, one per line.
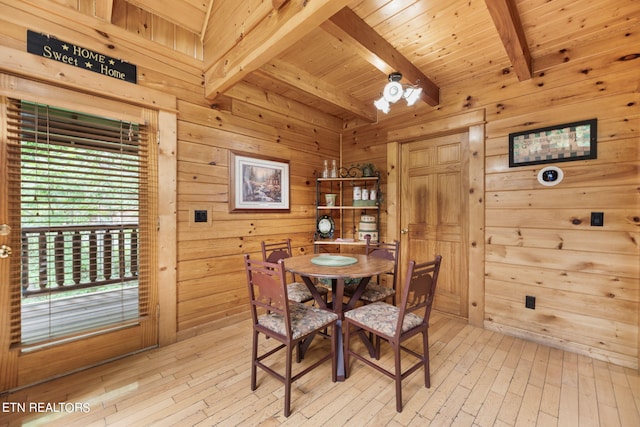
244, 254, 338, 417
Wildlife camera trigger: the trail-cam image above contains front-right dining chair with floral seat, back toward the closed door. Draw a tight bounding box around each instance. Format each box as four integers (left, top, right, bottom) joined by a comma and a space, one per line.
343, 255, 442, 412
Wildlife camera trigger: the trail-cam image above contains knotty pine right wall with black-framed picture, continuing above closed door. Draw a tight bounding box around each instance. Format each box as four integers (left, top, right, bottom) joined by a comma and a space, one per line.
343, 33, 640, 367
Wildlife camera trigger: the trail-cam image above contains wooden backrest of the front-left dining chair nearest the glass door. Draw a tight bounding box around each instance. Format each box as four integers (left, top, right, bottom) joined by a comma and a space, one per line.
244, 254, 291, 336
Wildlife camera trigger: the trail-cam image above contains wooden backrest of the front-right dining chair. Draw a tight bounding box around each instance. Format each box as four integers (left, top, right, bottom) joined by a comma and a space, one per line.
396, 255, 442, 336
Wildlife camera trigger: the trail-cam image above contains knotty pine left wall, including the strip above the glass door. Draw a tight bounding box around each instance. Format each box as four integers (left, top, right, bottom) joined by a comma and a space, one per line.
0, 1, 342, 337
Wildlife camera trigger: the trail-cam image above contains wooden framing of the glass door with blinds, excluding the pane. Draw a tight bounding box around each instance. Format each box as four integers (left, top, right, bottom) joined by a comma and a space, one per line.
0, 89, 158, 394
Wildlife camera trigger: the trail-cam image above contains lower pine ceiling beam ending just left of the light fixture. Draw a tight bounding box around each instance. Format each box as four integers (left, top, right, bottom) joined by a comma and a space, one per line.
259, 60, 377, 123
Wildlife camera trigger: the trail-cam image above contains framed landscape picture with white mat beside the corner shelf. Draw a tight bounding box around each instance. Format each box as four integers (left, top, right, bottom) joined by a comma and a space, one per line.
229, 151, 291, 212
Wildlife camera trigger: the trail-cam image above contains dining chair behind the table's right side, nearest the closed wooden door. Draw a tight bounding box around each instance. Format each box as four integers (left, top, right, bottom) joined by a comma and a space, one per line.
344, 239, 400, 305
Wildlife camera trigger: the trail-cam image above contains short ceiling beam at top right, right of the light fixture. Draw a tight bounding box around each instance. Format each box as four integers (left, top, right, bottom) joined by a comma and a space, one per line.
485, 0, 533, 81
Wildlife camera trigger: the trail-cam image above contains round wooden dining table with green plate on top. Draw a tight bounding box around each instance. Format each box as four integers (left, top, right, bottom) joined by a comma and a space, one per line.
284, 254, 394, 381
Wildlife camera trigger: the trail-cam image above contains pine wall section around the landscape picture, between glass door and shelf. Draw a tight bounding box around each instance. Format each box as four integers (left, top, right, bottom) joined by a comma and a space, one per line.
177, 89, 339, 335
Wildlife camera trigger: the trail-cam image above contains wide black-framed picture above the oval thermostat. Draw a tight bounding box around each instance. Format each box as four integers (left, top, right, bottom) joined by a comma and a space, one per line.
509, 119, 598, 168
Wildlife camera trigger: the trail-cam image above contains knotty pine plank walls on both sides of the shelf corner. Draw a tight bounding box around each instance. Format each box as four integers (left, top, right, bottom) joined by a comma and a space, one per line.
0, 2, 640, 367
